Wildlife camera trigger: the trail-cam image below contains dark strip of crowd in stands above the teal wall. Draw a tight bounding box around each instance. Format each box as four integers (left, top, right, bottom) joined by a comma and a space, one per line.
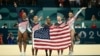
0, 0, 100, 8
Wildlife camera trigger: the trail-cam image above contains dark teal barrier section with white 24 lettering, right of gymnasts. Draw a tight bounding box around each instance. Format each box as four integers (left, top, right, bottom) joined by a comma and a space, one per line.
75, 28, 100, 44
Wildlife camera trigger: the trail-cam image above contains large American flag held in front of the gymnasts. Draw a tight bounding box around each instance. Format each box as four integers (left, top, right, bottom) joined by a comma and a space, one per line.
33, 24, 71, 50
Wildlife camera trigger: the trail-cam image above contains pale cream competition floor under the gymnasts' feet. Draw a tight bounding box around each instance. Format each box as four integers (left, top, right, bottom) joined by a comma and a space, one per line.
0, 44, 100, 56
